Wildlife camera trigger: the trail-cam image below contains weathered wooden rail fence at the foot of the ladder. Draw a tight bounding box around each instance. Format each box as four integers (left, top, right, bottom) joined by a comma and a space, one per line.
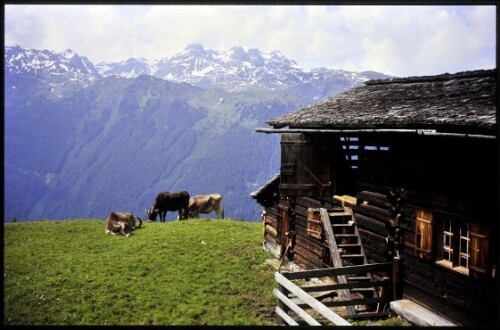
274, 262, 396, 325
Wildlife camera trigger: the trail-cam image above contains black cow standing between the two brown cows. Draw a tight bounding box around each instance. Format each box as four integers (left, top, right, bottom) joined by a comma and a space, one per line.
146, 191, 189, 222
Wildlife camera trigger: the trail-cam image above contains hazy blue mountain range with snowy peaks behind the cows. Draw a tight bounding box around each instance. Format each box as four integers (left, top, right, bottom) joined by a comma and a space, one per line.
4, 44, 389, 221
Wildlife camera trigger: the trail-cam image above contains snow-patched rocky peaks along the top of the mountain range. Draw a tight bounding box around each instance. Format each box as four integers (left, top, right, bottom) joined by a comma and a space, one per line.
4, 43, 392, 92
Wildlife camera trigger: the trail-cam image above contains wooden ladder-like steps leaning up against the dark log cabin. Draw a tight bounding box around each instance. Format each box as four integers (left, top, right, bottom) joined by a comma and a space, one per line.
320, 207, 378, 316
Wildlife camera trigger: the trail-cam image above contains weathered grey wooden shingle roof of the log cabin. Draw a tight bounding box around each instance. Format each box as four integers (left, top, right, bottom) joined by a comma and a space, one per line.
267, 69, 497, 135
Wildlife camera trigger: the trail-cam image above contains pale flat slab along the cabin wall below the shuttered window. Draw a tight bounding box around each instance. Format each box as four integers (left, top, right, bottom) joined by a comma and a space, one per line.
390, 299, 456, 327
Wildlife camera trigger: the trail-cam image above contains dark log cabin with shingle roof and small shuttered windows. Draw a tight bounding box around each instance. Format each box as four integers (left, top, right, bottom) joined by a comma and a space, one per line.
252, 69, 499, 326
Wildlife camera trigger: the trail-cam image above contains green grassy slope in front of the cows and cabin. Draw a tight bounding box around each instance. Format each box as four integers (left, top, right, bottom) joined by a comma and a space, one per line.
4, 220, 276, 325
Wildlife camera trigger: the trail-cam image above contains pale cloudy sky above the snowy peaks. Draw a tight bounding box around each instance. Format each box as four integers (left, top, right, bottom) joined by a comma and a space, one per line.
4, 5, 496, 76
